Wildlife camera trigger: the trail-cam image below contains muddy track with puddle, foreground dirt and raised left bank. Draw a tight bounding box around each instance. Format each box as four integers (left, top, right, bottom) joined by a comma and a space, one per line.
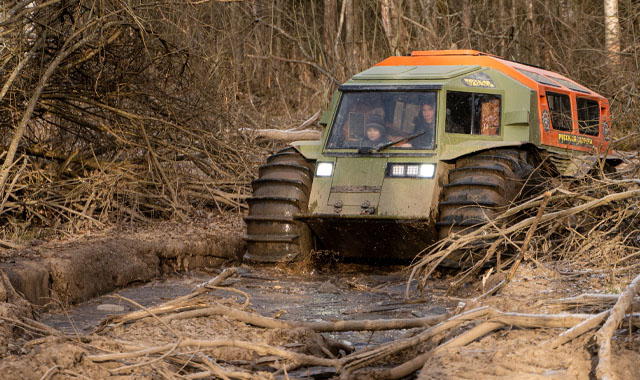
0, 215, 640, 380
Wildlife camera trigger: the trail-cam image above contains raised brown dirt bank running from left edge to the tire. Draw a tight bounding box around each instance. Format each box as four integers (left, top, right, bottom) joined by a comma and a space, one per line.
0, 215, 244, 306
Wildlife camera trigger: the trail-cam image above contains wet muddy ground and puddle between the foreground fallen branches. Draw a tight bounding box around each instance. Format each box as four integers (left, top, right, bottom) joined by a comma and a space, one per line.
11, 264, 640, 380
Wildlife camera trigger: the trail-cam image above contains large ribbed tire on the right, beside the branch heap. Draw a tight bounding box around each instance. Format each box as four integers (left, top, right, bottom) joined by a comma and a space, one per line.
437, 149, 534, 239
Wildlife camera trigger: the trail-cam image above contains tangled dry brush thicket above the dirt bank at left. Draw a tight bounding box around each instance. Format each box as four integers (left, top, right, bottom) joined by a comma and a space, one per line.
0, 0, 272, 240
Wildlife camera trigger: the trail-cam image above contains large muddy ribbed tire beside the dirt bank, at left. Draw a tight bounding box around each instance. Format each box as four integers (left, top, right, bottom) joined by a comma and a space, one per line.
244, 148, 315, 263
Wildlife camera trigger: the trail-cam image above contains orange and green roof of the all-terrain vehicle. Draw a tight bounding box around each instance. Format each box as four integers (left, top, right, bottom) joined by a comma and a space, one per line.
372, 50, 602, 98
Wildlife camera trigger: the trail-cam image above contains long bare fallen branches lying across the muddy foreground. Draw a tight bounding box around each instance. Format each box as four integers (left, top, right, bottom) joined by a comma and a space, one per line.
84, 271, 640, 379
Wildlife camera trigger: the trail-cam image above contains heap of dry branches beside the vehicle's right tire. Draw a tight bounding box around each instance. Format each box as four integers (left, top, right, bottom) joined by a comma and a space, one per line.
406, 165, 640, 298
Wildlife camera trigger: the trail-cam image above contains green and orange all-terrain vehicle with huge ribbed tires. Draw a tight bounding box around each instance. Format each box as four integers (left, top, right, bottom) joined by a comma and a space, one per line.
245, 50, 611, 262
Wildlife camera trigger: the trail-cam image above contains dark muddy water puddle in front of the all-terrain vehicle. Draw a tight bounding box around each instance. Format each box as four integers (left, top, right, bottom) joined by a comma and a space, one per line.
41, 265, 456, 348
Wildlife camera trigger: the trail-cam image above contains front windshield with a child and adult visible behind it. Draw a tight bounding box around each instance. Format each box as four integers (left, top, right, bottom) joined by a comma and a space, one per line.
327, 91, 437, 149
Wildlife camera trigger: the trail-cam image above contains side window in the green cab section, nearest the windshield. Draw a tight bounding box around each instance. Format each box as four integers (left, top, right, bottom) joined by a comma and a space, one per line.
445, 91, 501, 136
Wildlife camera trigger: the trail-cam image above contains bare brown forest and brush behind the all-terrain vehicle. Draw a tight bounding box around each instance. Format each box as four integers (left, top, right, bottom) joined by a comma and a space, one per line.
0, 0, 640, 242
